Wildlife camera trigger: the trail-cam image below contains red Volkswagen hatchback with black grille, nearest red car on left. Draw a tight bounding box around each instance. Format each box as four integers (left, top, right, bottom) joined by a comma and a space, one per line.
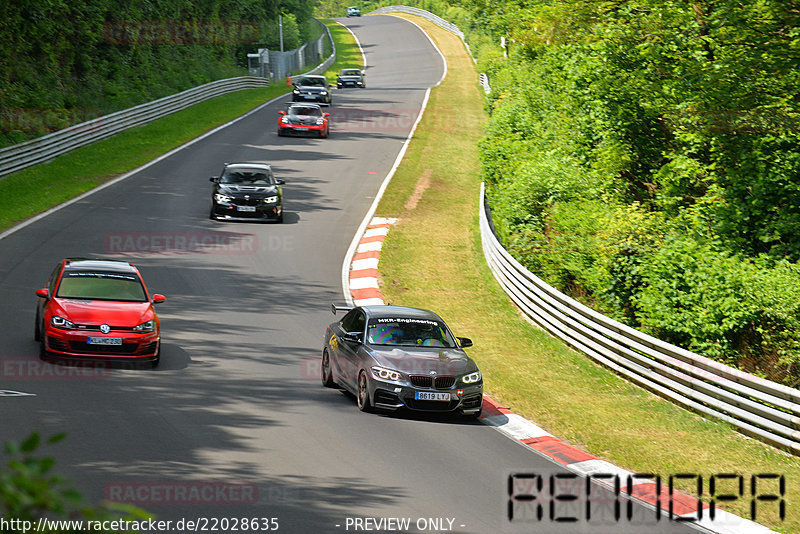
34, 259, 166, 367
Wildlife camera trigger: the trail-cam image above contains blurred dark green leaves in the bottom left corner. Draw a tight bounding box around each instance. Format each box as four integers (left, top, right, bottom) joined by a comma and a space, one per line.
0, 432, 150, 534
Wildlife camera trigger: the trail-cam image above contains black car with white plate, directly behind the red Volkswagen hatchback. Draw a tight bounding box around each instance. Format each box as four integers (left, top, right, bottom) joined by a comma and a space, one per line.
209, 163, 285, 222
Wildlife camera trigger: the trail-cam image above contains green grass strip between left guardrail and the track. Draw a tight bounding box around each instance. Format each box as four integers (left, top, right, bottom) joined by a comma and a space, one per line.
0, 21, 361, 230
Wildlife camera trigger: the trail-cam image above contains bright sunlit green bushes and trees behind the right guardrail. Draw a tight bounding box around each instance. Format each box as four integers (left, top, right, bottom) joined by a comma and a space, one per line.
321, 0, 800, 386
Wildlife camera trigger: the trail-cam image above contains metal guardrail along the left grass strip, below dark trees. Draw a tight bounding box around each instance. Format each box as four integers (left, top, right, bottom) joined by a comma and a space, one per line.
0, 21, 336, 178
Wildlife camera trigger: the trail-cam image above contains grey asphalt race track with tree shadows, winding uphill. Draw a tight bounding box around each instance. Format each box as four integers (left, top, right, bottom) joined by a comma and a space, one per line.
0, 16, 694, 534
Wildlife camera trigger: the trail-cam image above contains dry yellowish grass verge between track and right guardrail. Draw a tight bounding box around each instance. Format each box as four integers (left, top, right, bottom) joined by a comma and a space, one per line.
377, 13, 800, 532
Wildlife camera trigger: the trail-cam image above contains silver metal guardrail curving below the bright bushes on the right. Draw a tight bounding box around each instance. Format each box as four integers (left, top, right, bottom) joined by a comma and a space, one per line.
480, 184, 800, 454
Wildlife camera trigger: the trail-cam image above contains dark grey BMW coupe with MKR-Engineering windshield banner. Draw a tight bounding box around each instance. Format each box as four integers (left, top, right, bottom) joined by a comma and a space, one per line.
321, 305, 483, 417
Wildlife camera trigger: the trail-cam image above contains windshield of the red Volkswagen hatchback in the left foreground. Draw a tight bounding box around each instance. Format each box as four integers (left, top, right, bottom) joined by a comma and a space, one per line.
56, 271, 147, 302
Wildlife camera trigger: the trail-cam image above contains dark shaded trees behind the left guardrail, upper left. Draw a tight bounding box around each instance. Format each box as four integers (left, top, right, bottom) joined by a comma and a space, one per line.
0, 0, 319, 146
